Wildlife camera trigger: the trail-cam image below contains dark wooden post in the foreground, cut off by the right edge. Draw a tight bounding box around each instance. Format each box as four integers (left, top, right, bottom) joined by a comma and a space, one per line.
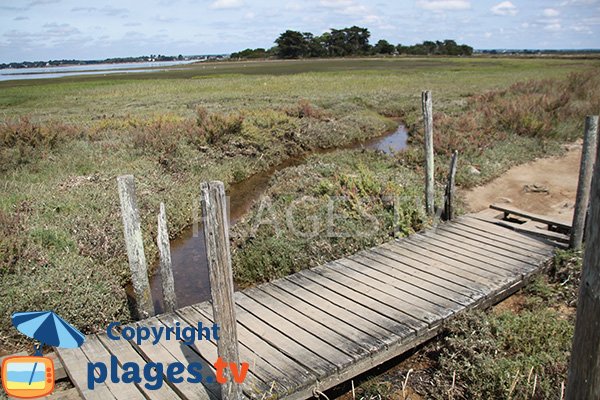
566, 123, 600, 400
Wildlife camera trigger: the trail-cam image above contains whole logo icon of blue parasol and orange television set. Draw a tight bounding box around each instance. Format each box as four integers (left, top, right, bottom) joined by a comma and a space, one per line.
2, 311, 85, 399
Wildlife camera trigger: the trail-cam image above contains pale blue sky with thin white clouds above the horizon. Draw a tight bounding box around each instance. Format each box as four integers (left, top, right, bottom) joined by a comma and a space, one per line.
0, 0, 600, 62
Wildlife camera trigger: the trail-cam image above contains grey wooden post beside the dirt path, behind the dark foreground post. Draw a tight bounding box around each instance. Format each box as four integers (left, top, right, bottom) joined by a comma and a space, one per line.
569, 116, 598, 249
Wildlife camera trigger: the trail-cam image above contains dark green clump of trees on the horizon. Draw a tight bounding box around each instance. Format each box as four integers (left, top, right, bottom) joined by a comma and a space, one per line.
231, 26, 473, 58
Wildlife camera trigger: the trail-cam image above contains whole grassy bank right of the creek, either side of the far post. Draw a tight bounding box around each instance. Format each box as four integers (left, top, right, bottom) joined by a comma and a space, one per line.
235, 72, 600, 284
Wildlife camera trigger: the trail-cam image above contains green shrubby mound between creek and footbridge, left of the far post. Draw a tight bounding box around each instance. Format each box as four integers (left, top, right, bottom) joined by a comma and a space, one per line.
232, 150, 427, 285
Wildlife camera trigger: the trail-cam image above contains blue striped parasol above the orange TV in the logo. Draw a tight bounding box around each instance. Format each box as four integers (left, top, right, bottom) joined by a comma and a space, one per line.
12, 311, 85, 349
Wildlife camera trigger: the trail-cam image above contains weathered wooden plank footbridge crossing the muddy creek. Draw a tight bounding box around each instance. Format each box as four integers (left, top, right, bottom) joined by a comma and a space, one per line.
57, 213, 558, 399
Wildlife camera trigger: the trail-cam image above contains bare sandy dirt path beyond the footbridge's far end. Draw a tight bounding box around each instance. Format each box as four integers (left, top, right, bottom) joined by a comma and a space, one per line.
461, 142, 581, 222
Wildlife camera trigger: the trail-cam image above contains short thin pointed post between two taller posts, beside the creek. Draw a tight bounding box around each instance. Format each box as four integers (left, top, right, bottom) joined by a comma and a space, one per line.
156, 203, 177, 312
